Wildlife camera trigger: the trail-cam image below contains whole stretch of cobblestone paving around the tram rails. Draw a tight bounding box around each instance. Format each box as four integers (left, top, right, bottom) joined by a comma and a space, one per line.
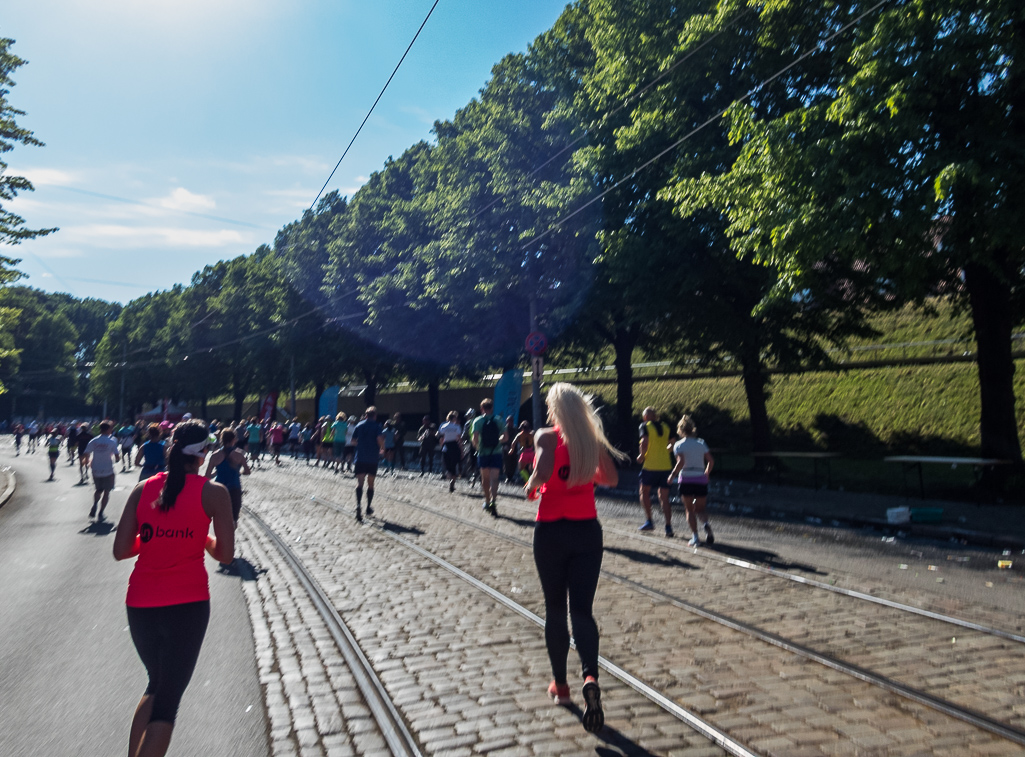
234, 466, 1025, 756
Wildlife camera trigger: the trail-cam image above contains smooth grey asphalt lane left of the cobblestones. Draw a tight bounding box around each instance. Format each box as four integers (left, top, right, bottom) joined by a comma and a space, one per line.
0, 445, 269, 757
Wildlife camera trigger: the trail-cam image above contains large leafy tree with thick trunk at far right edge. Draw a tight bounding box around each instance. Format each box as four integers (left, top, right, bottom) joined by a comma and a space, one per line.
674, 0, 1025, 460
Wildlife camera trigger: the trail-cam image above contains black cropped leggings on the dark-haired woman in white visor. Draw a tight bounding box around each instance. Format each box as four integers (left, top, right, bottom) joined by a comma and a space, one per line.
127, 599, 210, 723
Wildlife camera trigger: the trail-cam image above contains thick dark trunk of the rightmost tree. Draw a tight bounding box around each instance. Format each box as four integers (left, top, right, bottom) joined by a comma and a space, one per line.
965, 262, 1022, 470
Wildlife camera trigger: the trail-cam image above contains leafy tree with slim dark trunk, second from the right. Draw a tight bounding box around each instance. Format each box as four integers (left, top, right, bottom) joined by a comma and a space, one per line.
585, 0, 889, 451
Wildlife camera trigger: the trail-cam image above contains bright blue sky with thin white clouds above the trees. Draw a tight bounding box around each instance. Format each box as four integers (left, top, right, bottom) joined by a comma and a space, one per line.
0, 0, 566, 302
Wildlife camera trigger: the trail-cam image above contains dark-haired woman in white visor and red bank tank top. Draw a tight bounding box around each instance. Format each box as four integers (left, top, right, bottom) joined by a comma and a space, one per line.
114, 420, 235, 757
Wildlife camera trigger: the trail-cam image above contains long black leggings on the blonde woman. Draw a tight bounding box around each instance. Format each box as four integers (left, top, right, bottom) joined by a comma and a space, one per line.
534, 519, 603, 683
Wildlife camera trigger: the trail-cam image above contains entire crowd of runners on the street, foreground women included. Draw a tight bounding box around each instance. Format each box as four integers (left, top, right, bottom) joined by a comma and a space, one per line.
11, 393, 714, 755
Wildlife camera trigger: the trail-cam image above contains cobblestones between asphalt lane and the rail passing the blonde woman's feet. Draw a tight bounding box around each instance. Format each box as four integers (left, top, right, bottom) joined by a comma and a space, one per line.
234, 471, 724, 757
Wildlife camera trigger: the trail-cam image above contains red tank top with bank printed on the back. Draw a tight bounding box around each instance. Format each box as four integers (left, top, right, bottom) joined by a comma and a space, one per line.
125, 473, 210, 607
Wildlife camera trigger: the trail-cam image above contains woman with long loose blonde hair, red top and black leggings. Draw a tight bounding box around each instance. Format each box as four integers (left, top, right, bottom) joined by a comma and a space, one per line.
526, 383, 626, 733
